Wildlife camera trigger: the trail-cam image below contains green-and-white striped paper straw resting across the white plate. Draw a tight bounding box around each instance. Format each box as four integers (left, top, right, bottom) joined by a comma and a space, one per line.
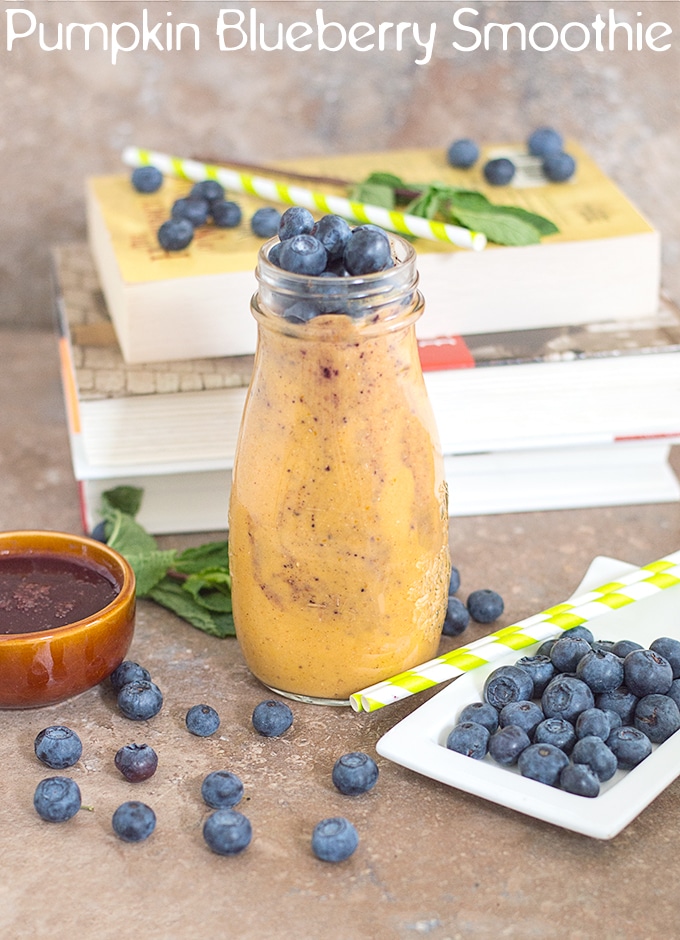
349, 551, 680, 712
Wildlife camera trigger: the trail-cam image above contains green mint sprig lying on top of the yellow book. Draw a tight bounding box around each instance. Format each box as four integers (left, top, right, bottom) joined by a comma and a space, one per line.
352, 172, 559, 246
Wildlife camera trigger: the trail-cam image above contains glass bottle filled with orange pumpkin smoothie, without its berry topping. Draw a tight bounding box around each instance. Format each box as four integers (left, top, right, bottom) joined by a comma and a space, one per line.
229, 236, 450, 704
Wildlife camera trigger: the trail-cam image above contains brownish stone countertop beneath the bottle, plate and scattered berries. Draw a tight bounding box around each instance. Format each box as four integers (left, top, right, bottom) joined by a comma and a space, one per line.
0, 331, 680, 940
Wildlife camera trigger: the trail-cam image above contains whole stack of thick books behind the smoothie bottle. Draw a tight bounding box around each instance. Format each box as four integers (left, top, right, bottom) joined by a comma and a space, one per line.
54, 143, 680, 534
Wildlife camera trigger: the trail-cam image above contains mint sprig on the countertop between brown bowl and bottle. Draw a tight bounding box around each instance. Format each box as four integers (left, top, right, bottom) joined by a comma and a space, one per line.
101, 486, 235, 637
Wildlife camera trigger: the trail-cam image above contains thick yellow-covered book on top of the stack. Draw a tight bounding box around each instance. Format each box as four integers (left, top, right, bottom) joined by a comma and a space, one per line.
86, 142, 661, 362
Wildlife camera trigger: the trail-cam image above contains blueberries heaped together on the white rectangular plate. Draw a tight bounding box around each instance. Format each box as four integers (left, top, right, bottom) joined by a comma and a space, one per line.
446, 626, 680, 797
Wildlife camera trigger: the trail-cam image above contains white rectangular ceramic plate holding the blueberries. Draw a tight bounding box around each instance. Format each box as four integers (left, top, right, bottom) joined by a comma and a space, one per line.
376, 557, 680, 839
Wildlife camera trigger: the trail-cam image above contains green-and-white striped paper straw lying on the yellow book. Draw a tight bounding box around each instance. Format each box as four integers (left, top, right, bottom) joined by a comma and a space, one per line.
122, 147, 486, 251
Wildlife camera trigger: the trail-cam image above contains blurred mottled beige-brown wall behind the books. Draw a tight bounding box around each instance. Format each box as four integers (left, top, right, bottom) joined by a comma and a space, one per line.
0, 0, 680, 328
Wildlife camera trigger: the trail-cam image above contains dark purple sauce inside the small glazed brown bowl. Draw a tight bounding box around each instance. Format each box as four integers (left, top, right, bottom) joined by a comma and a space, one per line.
0, 554, 119, 634
